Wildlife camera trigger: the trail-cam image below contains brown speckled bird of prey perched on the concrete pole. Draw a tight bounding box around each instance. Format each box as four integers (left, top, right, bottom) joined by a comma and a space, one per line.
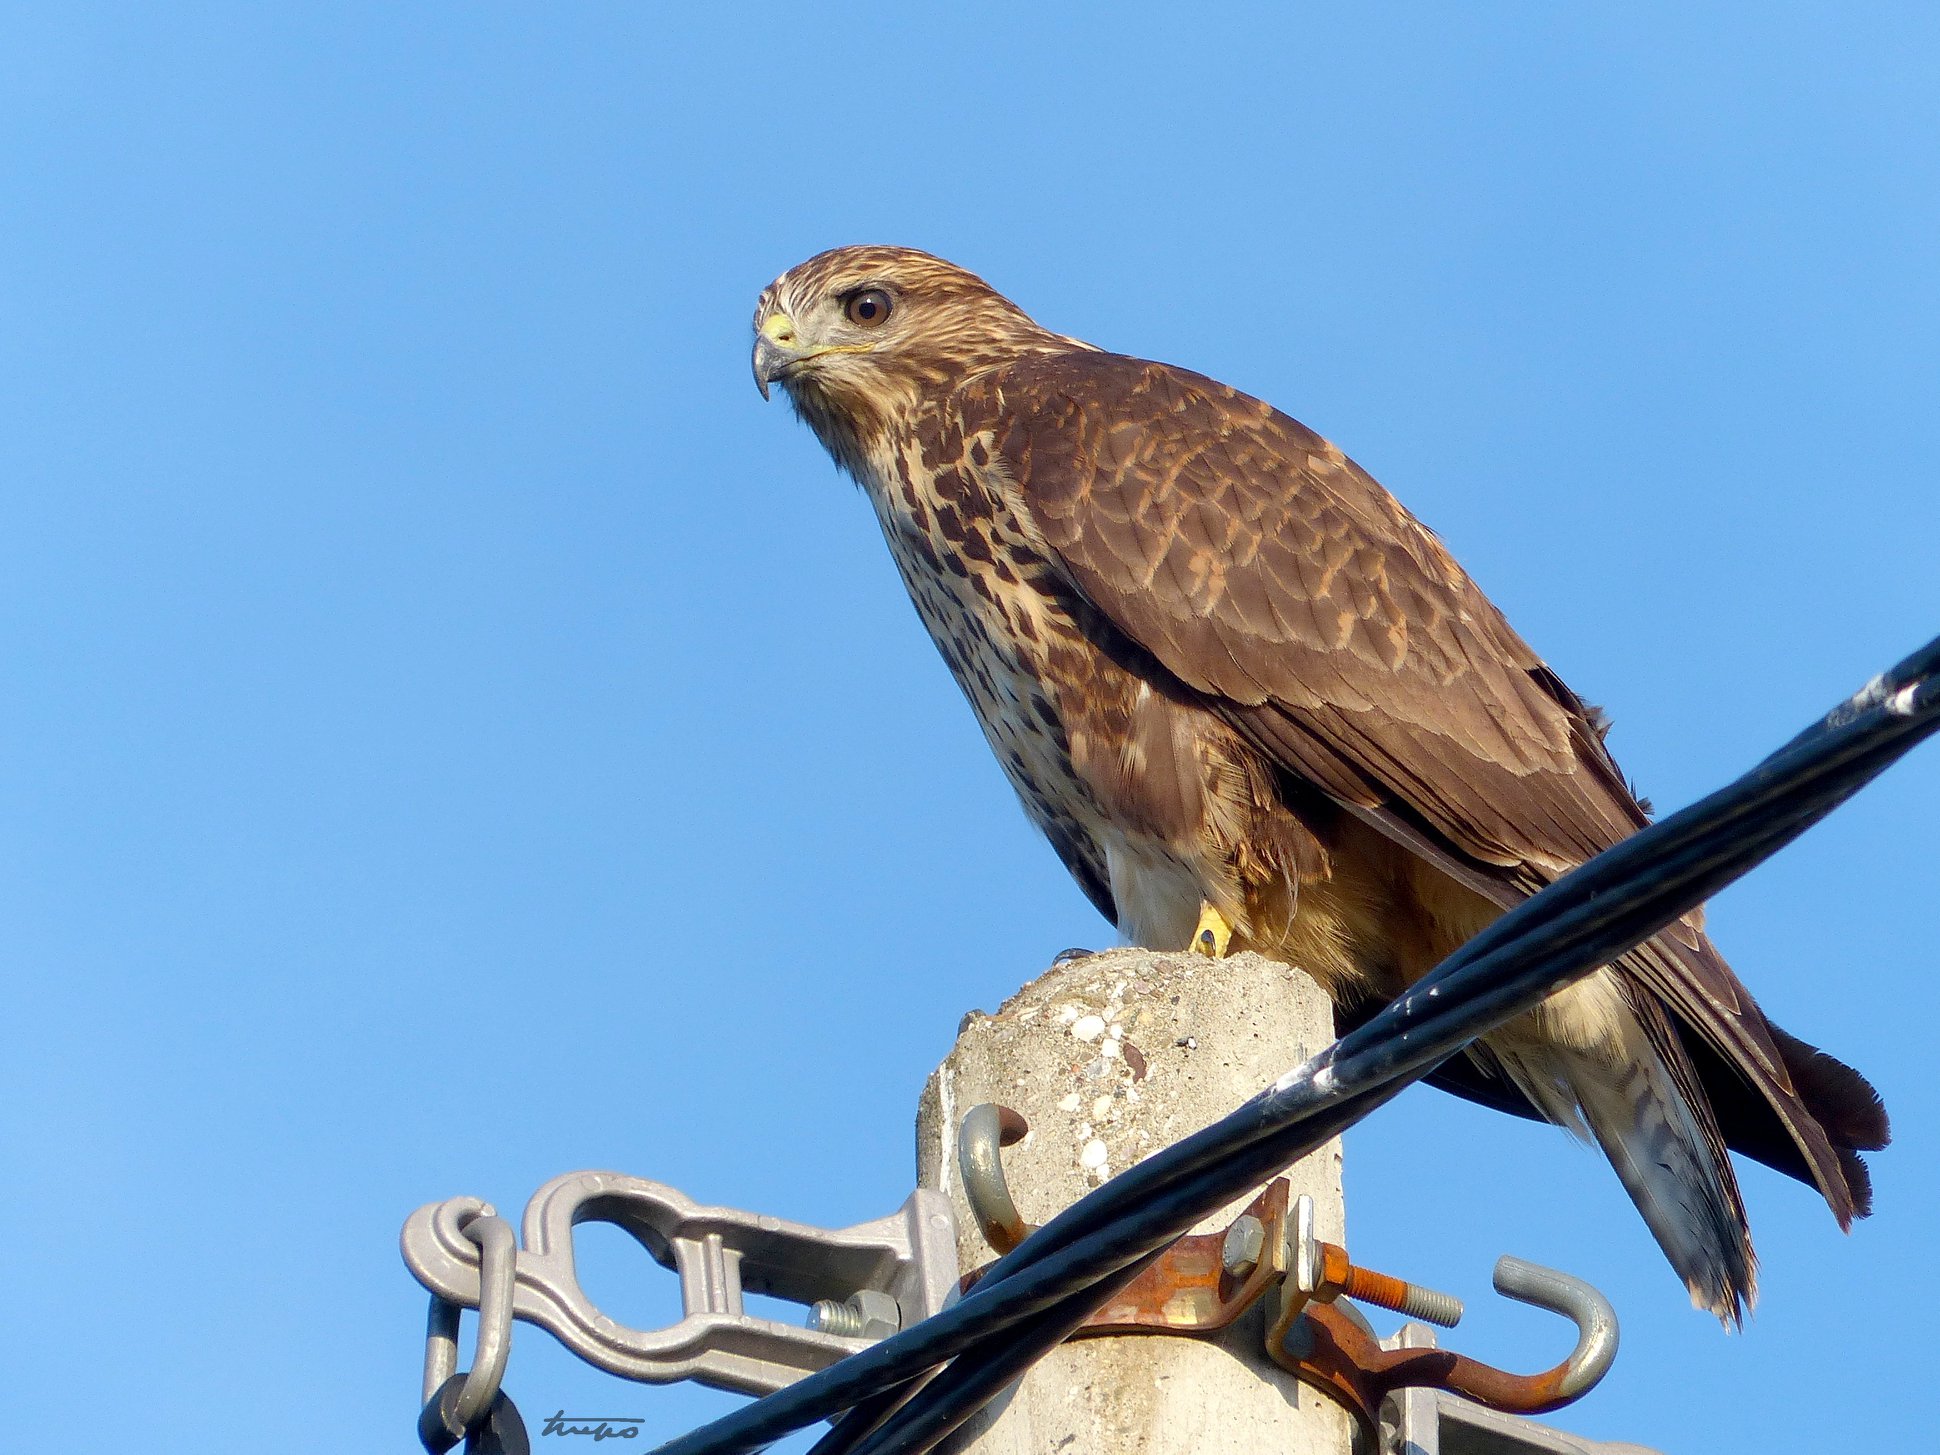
755, 246, 1888, 1325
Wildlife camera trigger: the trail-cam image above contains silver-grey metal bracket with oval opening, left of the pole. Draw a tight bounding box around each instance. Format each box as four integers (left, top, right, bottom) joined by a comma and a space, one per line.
400, 1172, 956, 1395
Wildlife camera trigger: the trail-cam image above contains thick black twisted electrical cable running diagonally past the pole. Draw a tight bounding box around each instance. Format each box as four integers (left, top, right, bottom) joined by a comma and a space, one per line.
656, 640, 1940, 1455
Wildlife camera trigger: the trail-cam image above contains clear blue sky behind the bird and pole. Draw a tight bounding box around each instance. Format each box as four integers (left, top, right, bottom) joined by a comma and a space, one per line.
0, 0, 1940, 1451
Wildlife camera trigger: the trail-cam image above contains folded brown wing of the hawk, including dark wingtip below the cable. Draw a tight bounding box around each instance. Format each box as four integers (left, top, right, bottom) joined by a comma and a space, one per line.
977, 353, 1886, 1224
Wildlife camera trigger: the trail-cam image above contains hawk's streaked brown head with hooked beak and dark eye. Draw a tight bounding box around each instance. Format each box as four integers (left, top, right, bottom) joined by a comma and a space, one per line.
755, 246, 1073, 468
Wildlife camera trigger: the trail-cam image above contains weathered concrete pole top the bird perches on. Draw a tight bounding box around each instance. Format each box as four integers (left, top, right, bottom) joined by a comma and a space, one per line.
916, 951, 1354, 1455
